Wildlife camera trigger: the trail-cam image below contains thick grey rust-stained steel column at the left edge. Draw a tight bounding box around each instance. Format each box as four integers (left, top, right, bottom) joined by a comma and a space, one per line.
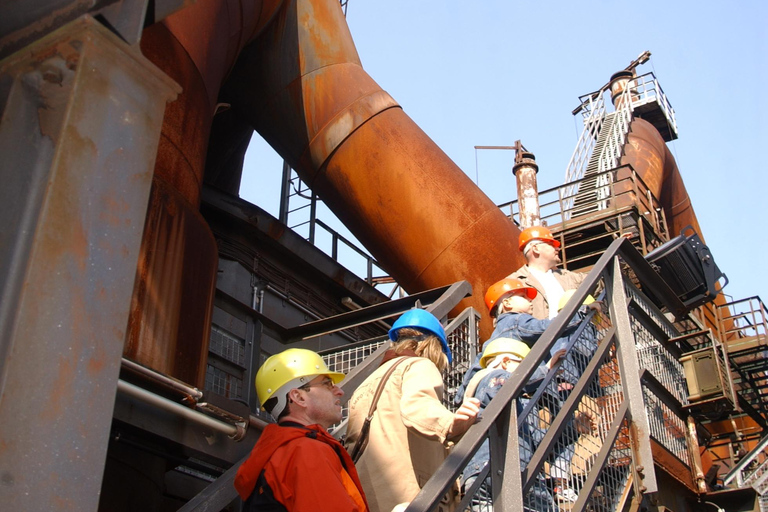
0, 17, 179, 511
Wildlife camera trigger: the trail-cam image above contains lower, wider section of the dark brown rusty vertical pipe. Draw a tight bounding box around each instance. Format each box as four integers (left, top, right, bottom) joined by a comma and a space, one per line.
123, 176, 218, 388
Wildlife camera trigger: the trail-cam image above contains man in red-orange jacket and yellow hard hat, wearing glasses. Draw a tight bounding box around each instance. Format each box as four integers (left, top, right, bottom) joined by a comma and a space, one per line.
235, 348, 368, 512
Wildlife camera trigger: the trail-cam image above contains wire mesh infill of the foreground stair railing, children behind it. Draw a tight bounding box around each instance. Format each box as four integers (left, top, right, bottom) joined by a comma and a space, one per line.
465, 322, 632, 512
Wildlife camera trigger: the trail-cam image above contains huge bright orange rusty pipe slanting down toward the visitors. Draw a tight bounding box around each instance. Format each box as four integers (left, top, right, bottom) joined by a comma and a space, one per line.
216, 0, 522, 335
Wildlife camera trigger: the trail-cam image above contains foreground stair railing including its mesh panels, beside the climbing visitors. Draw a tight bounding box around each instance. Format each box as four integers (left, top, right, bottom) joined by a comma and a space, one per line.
406, 239, 690, 512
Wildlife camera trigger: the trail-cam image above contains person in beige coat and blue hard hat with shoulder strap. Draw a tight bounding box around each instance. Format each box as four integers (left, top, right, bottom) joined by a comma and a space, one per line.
345, 309, 480, 512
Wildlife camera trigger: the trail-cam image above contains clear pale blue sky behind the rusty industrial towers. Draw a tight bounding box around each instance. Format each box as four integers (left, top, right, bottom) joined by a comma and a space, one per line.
241, 0, 768, 308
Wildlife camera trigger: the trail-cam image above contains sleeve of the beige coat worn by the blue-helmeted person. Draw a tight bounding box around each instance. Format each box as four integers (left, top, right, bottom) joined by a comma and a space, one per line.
400, 358, 453, 443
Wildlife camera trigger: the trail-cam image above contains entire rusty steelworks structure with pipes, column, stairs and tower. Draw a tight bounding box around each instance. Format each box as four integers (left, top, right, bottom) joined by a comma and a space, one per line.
0, 0, 768, 512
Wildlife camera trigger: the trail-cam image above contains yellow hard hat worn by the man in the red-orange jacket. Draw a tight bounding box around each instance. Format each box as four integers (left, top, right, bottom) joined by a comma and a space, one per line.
255, 348, 344, 418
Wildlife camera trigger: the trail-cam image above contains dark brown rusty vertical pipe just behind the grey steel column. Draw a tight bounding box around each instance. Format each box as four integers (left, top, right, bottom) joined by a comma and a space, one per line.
124, 0, 280, 387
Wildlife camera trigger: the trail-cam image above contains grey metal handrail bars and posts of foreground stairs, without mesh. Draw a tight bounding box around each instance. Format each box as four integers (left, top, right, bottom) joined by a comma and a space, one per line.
406, 239, 684, 512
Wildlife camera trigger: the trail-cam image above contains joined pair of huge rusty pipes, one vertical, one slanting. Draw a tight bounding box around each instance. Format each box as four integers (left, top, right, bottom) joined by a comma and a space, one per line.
126, 0, 522, 376
